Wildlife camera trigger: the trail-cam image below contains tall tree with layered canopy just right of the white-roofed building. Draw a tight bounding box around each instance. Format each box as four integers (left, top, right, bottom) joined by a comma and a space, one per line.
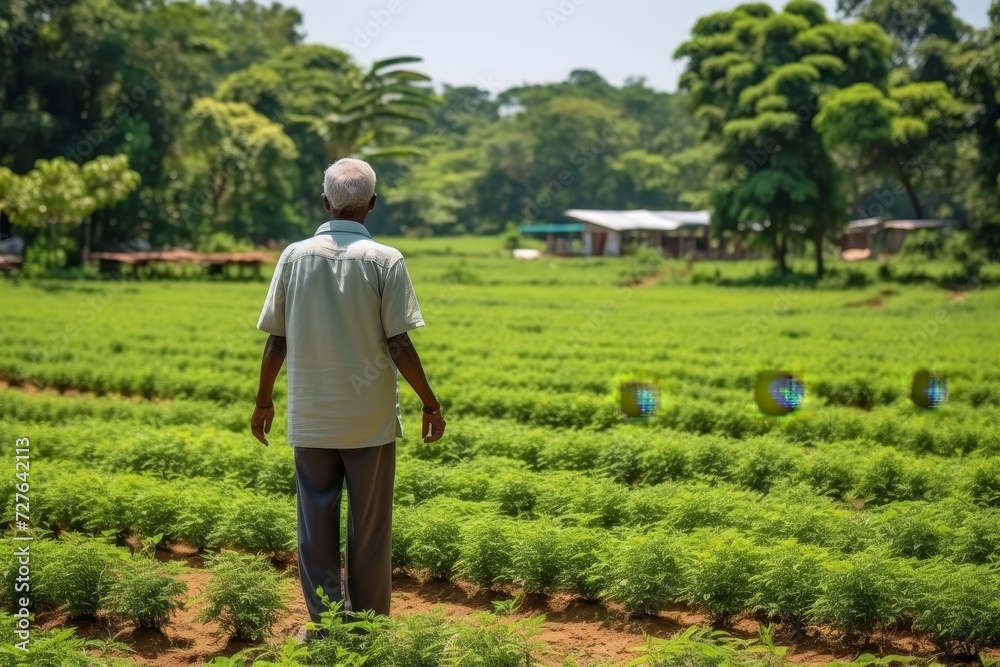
675, 0, 892, 275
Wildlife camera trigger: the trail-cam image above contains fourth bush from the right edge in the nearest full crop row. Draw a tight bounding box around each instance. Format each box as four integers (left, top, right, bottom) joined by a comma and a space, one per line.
682, 531, 762, 624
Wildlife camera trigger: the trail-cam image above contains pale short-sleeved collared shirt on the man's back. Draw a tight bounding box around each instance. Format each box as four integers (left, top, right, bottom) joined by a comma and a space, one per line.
257, 220, 424, 449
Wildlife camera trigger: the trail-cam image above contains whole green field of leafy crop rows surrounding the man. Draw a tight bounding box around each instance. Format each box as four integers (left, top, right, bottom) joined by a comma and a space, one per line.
0, 239, 1000, 666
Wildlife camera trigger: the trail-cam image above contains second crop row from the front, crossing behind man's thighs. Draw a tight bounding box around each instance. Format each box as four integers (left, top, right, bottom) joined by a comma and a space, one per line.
13, 458, 1000, 563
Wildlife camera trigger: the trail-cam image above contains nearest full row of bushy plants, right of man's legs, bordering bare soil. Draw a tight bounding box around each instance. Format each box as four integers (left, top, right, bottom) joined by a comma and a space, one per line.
394, 508, 1000, 655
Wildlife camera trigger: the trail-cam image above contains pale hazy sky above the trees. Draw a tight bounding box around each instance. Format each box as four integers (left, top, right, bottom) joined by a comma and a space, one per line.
284, 0, 989, 92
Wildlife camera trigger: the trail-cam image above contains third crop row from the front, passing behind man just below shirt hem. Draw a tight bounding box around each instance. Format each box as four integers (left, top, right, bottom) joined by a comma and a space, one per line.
7, 392, 1000, 506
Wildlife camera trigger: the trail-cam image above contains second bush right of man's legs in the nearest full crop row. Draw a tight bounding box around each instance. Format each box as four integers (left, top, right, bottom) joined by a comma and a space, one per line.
455, 516, 521, 588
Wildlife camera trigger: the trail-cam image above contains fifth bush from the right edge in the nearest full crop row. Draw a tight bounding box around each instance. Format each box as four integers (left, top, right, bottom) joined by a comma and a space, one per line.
599, 531, 682, 615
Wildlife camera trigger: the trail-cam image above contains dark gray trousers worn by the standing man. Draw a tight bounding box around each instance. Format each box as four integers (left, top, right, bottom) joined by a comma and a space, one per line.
293, 441, 396, 621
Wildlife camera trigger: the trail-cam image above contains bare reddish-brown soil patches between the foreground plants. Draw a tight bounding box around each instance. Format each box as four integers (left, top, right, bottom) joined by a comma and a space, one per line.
38, 551, 996, 667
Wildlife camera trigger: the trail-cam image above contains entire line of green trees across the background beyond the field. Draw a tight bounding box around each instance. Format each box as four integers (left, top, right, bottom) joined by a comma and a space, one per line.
0, 0, 1000, 272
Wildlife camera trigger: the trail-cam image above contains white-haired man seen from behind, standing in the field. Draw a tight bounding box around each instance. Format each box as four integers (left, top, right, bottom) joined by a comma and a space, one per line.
250, 158, 445, 621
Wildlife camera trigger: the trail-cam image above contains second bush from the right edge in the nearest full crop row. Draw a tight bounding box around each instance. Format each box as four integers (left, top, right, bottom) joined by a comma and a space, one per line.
811, 550, 911, 637
